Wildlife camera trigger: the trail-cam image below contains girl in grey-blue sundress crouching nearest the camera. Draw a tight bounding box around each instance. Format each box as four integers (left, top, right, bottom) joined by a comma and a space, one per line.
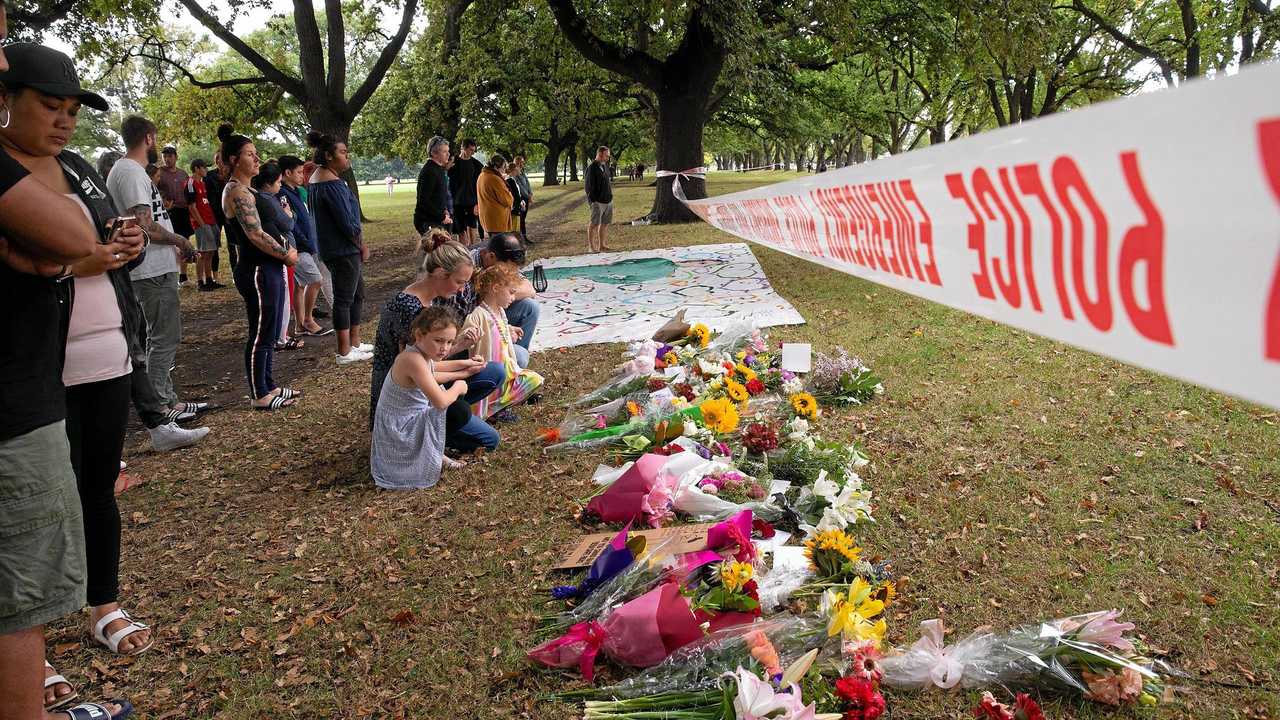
369, 307, 485, 489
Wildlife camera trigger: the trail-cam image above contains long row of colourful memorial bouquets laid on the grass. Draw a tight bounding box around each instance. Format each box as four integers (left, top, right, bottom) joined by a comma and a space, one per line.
529, 313, 1170, 720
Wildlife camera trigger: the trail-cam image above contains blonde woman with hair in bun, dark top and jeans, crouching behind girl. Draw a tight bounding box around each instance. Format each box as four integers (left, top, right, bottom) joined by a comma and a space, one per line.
369, 228, 506, 452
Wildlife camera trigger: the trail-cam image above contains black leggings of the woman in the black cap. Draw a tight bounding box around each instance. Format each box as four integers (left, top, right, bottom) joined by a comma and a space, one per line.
67, 375, 133, 607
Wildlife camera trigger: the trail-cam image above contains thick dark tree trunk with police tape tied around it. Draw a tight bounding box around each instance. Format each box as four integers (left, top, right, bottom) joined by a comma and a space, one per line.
649, 92, 707, 223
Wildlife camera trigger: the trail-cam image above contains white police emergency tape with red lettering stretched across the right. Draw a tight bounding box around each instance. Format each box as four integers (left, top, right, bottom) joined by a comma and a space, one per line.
689, 65, 1280, 407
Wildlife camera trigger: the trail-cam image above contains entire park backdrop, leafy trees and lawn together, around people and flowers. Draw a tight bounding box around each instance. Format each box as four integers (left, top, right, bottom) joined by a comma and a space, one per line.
9, 0, 1280, 719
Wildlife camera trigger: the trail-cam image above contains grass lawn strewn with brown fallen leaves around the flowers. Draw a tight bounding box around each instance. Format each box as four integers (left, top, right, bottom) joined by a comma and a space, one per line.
50, 173, 1280, 719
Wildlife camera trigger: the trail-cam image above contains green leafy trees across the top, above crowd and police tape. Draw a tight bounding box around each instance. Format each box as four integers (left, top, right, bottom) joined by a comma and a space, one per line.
27, 0, 1280, 220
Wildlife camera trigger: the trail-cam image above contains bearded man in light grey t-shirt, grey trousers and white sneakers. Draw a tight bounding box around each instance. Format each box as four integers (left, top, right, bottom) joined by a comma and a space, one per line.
106, 115, 199, 414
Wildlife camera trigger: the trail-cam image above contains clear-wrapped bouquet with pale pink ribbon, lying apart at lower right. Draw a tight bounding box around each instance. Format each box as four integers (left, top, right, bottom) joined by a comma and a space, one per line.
882, 610, 1171, 705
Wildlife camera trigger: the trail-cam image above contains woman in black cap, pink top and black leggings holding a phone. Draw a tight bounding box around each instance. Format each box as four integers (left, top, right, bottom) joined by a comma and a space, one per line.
0, 44, 141, 719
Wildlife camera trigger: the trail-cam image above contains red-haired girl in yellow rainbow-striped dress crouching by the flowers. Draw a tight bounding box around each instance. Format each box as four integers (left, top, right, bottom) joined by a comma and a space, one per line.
462, 263, 543, 421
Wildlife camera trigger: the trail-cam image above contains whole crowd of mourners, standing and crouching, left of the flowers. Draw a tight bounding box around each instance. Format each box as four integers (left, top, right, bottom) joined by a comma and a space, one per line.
0, 18, 612, 720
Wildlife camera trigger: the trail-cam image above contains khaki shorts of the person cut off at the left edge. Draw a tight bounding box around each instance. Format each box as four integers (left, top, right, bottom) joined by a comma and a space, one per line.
0, 421, 84, 635
